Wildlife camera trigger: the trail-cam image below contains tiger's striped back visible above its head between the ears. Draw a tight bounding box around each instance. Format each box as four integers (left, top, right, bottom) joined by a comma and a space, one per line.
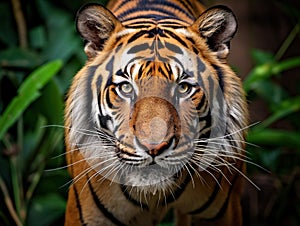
108, 0, 204, 26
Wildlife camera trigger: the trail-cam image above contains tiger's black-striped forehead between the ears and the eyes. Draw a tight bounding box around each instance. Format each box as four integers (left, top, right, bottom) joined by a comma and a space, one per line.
95, 26, 208, 82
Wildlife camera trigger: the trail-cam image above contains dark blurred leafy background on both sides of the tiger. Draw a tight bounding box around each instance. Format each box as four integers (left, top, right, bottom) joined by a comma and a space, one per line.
0, 0, 300, 226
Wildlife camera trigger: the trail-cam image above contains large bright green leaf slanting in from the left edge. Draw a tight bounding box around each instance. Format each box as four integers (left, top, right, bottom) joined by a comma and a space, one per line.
0, 60, 62, 139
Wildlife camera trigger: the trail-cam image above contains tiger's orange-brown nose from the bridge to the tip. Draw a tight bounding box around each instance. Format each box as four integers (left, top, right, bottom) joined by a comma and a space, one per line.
129, 96, 181, 157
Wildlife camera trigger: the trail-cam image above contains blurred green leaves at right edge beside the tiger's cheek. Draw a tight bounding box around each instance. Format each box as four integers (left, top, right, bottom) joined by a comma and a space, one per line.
244, 44, 300, 170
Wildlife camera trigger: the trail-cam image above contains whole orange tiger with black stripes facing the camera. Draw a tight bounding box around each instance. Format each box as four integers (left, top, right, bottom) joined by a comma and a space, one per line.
64, 0, 249, 226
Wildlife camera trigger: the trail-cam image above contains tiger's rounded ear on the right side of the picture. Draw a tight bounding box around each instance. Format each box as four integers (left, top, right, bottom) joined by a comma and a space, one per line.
192, 6, 237, 60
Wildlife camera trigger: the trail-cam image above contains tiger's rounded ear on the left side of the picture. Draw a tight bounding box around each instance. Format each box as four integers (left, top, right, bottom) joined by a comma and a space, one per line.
76, 4, 122, 58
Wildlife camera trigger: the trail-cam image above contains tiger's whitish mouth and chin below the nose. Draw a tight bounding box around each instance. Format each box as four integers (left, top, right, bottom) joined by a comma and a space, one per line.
113, 143, 191, 195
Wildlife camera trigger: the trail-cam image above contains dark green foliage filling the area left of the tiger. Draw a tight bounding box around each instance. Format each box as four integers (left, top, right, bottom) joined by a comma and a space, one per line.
0, 0, 91, 226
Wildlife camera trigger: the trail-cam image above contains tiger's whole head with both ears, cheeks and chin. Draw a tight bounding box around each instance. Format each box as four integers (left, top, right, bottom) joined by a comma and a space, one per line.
66, 5, 247, 192
